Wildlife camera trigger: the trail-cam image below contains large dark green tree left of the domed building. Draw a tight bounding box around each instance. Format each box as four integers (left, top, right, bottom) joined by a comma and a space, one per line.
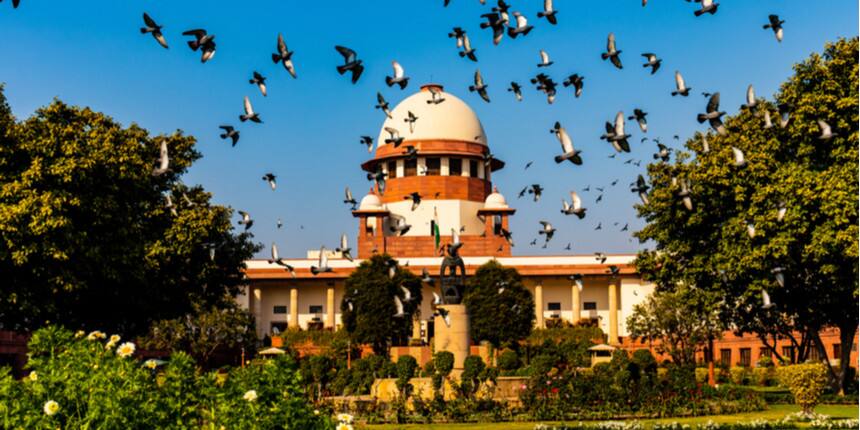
0, 91, 256, 335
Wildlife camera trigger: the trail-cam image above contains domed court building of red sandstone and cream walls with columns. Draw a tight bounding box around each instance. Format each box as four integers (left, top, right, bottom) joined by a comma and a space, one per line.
237, 85, 857, 366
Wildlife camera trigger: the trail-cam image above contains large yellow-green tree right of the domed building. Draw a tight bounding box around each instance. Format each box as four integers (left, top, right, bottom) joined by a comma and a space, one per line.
636, 38, 858, 388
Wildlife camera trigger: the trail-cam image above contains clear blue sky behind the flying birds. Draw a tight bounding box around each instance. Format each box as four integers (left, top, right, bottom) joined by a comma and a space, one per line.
0, 0, 858, 257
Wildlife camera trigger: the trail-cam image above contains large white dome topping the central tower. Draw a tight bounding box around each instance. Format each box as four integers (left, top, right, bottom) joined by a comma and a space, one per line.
376, 85, 487, 147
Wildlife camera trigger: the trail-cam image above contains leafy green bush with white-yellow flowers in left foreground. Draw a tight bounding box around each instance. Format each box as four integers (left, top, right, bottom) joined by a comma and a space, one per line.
0, 327, 331, 429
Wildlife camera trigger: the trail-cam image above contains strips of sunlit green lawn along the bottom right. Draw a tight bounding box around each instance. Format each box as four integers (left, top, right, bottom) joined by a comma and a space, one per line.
358, 405, 858, 430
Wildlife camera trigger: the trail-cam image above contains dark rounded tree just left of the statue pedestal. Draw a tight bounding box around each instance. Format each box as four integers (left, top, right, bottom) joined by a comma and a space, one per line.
340, 255, 421, 357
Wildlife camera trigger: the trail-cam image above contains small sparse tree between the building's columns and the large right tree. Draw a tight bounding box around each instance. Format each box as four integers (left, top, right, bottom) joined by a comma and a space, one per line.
627, 288, 726, 366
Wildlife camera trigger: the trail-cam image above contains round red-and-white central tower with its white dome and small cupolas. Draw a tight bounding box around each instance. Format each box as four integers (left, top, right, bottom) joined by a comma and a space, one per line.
353, 84, 515, 258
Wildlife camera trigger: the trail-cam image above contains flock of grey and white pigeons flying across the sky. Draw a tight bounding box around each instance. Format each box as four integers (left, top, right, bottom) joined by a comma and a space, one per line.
0, 0, 836, 315
